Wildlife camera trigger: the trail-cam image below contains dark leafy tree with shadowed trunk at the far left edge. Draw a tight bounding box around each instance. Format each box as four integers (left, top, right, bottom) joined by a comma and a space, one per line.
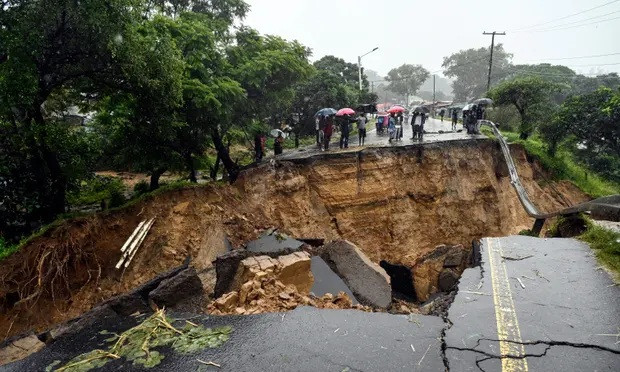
0, 0, 180, 227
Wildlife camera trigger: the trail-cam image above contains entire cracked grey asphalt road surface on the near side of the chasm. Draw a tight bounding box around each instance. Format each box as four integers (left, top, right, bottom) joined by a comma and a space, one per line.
0, 236, 620, 372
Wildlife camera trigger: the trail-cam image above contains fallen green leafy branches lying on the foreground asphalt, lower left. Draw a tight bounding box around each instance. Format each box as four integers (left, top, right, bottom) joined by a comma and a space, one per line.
48, 310, 232, 372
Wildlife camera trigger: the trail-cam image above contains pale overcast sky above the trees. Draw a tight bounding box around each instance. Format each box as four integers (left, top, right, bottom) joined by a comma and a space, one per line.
244, 0, 620, 75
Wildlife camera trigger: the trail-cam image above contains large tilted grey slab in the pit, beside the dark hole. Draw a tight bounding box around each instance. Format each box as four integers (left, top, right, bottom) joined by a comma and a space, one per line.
321, 240, 392, 308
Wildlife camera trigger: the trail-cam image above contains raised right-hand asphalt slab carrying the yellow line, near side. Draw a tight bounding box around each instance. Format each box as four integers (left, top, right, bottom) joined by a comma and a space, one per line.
444, 236, 620, 371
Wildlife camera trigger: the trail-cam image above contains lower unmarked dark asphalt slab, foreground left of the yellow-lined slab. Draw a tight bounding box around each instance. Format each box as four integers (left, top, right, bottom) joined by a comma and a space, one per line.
2, 307, 444, 372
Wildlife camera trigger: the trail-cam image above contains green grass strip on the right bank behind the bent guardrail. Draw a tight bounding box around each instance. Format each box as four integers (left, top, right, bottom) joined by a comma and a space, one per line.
482, 128, 620, 198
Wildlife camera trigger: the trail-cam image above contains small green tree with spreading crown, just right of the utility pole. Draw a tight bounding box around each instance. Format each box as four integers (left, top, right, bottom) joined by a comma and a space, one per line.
489, 76, 558, 139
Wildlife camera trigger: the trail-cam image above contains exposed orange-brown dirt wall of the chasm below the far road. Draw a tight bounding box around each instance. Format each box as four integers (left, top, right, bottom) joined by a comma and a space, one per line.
0, 140, 587, 339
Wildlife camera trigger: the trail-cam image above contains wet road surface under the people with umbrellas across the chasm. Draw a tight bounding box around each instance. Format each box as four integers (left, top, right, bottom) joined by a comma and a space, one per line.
277, 118, 487, 160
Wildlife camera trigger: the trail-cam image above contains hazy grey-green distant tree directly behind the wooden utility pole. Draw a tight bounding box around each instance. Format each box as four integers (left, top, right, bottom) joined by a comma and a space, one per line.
441, 44, 512, 102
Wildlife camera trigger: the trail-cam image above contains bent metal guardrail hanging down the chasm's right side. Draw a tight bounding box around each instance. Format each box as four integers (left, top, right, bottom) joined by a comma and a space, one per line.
480, 120, 620, 235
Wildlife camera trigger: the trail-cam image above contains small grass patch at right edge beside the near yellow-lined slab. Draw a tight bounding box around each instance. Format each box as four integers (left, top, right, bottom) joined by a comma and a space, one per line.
579, 221, 620, 281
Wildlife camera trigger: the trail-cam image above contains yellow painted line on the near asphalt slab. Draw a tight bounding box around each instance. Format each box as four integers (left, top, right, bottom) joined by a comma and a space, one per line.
487, 238, 528, 372
